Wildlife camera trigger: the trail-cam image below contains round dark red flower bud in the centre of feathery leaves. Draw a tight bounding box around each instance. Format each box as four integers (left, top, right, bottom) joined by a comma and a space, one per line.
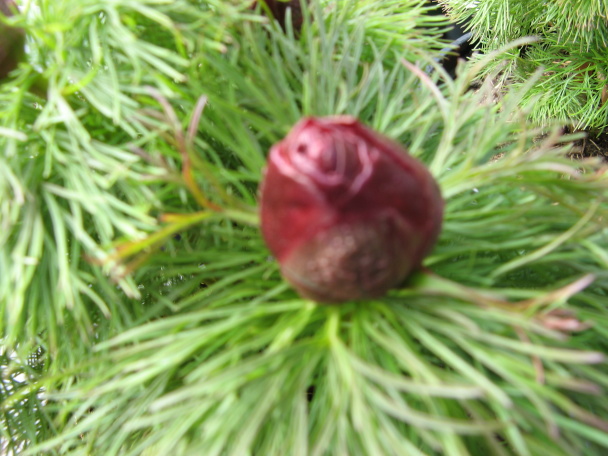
260, 116, 443, 303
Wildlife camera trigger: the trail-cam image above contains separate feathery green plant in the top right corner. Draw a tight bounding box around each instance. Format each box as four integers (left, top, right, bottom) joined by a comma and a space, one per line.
440, 0, 608, 131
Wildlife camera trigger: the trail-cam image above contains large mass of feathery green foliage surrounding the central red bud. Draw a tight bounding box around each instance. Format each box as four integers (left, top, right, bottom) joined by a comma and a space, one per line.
0, 0, 608, 456
